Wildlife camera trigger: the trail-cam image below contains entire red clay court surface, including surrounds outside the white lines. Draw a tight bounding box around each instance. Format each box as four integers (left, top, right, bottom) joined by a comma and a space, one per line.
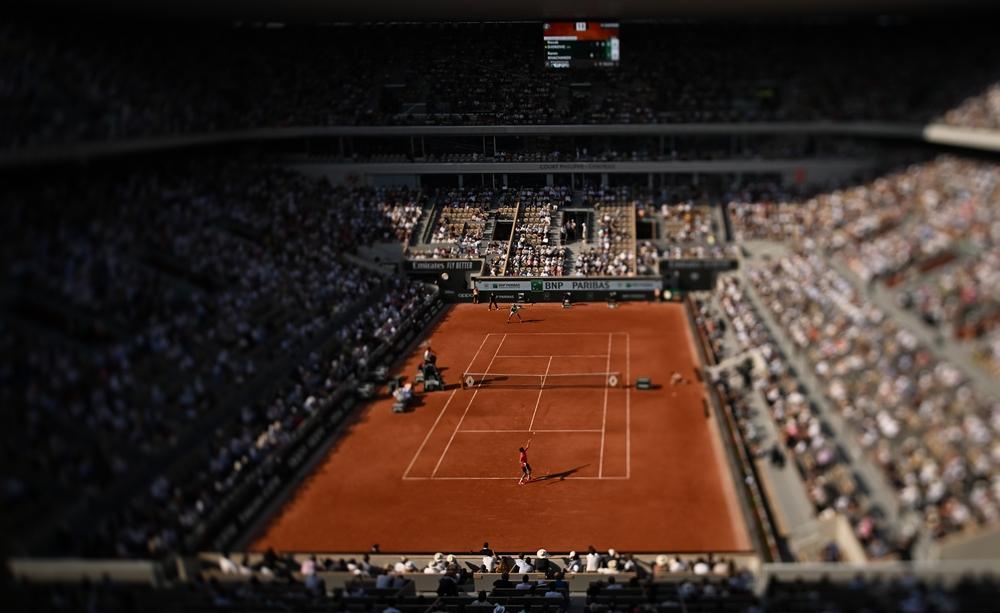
253, 303, 751, 553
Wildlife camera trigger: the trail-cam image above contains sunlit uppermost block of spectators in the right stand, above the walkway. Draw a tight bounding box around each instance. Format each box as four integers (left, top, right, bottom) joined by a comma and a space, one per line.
728, 156, 1000, 371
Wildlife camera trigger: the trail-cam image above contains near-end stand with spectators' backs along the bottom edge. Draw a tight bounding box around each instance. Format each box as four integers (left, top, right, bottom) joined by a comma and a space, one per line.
8, 554, 998, 613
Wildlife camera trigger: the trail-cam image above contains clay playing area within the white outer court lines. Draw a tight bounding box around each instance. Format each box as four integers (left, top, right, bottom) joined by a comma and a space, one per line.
403, 332, 631, 481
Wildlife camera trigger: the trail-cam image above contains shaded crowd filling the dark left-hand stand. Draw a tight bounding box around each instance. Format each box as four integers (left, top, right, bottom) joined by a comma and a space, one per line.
0, 160, 438, 555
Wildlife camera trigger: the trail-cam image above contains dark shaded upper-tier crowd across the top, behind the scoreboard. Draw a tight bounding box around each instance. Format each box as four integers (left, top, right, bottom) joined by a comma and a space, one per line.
0, 21, 1000, 148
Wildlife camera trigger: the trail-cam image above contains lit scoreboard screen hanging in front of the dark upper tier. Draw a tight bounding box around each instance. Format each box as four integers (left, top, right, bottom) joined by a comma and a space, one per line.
543, 21, 621, 69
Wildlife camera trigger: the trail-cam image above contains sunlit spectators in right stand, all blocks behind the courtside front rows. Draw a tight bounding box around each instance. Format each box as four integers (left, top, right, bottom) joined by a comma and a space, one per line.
728, 157, 1000, 536
